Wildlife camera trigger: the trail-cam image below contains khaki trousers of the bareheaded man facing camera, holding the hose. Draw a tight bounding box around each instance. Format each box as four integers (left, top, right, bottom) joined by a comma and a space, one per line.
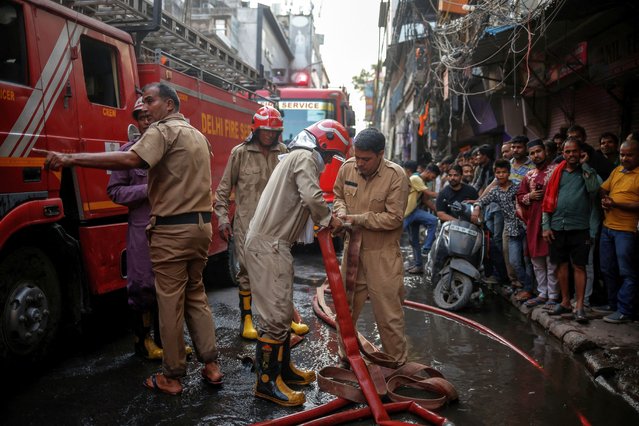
338, 243, 407, 365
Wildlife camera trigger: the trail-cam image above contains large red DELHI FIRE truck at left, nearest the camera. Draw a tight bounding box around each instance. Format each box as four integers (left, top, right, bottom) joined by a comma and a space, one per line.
0, 0, 260, 361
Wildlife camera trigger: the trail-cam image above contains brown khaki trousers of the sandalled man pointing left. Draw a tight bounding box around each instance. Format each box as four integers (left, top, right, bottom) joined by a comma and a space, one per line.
148, 219, 217, 378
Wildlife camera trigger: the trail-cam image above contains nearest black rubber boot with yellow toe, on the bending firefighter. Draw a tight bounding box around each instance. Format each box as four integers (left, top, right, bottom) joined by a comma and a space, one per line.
254, 337, 306, 407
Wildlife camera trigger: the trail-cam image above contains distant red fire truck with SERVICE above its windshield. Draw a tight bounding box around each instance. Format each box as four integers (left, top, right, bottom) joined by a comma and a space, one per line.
258, 86, 355, 203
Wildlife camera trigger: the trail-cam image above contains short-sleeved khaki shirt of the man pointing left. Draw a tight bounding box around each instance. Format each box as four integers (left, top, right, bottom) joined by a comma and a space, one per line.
131, 113, 213, 216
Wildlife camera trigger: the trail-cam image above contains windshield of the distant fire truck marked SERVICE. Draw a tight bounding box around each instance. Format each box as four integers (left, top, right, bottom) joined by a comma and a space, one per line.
279, 99, 335, 145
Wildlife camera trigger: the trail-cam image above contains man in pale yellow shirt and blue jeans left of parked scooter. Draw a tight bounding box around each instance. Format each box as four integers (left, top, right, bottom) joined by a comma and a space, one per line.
403, 161, 439, 274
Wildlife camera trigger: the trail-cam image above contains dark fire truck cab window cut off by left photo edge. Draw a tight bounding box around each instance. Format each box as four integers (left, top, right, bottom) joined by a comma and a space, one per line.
0, 2, 29, 85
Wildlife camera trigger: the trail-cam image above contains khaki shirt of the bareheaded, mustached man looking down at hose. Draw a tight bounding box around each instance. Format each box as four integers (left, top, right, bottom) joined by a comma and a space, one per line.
333, 158, 409, 249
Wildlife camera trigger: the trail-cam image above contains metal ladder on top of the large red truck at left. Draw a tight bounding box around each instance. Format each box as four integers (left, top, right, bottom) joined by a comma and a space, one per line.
56, 0, 272, 90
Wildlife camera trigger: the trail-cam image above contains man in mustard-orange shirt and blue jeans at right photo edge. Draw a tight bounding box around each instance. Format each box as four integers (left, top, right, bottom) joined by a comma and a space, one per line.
600, 136, 639, 324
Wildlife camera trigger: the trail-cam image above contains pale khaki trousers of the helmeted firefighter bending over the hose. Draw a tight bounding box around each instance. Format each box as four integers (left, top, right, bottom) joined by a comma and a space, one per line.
244, 235, 293, 342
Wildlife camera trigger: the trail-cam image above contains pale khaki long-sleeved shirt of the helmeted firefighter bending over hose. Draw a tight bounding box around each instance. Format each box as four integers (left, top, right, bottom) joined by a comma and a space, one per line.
247, 149, 331, 244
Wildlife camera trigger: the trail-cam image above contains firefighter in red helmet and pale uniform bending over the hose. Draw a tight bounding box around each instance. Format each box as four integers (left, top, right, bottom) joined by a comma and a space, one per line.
245, 120, 350, 406
